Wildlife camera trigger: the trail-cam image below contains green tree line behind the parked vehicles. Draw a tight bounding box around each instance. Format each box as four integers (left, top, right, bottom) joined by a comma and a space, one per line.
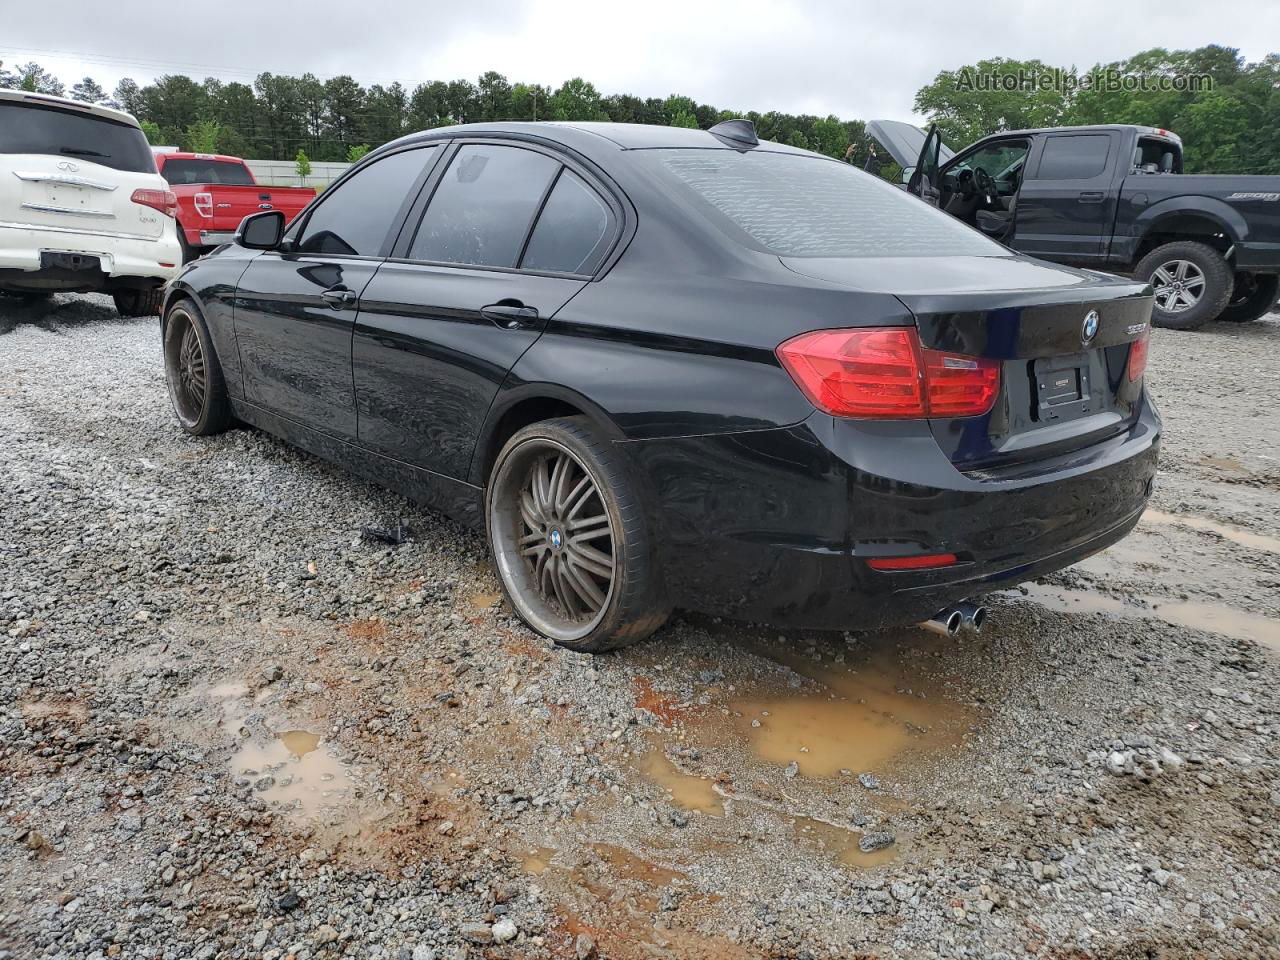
0, 45, 1280, 177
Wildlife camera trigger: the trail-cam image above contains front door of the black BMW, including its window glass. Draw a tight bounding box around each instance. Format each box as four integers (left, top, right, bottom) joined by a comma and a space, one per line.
236, 146, 439, 439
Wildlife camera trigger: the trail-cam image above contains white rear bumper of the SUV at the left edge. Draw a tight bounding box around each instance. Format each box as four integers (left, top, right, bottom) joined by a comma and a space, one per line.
0, 223, 182, 291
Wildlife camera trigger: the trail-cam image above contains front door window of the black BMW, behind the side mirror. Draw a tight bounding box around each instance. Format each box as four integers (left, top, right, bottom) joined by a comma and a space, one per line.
298, 147, 438, 257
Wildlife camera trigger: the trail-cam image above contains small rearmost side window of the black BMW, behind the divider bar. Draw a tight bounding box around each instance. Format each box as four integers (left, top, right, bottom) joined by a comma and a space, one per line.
520, 170, 612, 274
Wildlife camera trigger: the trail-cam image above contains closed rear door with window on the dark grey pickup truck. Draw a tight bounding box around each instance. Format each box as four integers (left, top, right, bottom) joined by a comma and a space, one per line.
1010, 132, 1120, 264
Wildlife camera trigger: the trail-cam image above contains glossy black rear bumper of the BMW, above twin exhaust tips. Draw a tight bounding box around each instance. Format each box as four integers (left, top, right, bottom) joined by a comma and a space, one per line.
623, 402, 1160, 630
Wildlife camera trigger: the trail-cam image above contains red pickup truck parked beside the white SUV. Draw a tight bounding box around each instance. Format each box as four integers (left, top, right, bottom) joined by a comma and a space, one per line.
156, 152, 316, 264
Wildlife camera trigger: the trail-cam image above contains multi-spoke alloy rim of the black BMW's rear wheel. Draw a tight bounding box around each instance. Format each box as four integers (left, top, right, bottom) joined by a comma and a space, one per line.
490, 438, 617, 641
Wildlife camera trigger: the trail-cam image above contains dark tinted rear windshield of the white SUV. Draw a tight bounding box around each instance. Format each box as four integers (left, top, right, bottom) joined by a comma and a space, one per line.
0, 100, 156, 173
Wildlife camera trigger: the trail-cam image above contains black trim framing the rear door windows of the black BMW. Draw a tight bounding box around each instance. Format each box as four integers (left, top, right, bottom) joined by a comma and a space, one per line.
385, 134, 635, 280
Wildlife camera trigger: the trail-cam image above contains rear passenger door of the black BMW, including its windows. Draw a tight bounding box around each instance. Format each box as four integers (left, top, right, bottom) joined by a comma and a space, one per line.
352, 141, 620, 479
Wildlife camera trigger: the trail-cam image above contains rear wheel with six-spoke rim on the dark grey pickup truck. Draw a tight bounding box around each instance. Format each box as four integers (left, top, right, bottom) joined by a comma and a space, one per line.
1133, 241, 1234, 330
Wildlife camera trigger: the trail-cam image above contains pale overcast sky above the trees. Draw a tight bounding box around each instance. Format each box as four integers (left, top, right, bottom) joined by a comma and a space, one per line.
0, 0, 1280, 119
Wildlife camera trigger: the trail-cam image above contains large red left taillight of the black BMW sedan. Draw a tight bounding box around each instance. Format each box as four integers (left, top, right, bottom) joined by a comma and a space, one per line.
778, 326, 1000, 419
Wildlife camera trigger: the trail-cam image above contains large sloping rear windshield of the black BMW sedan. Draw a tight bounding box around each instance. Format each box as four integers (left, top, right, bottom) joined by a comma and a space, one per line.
644, 150, 1009, 257
